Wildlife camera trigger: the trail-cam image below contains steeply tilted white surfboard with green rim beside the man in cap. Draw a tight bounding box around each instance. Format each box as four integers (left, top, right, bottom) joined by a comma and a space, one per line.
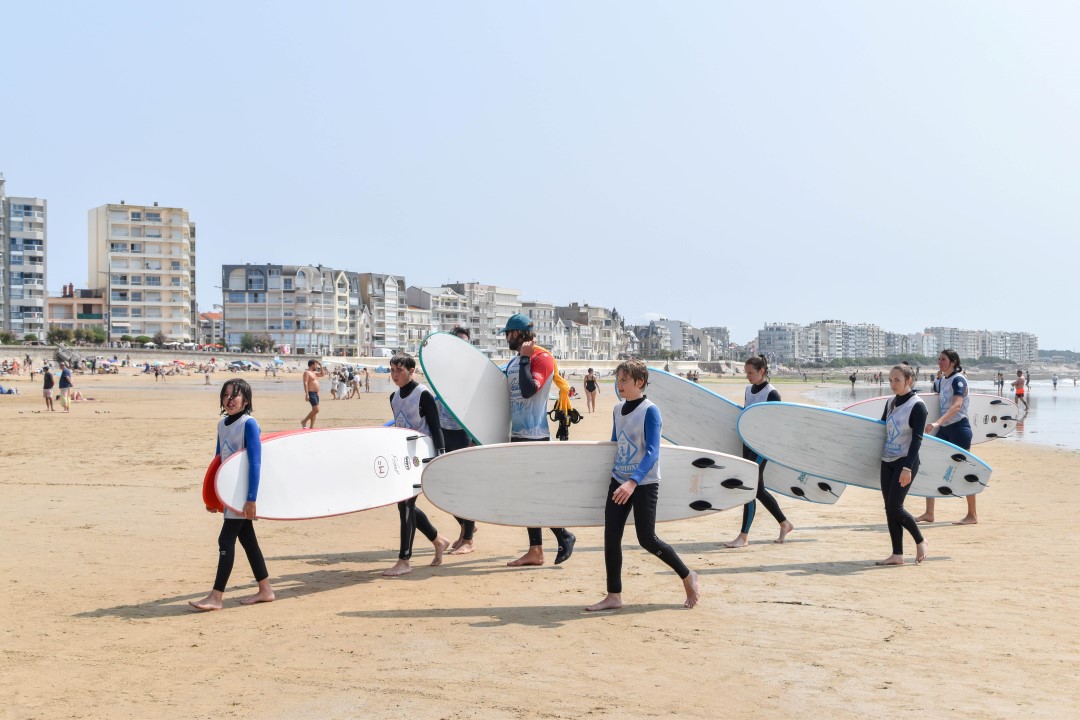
420, 332, 510, 445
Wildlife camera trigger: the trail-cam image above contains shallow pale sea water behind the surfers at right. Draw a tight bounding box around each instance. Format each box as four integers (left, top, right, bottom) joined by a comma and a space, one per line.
807, 378, 1080, 450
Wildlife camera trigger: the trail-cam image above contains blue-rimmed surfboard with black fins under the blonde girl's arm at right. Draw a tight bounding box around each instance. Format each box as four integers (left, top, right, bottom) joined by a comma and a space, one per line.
739, 403, 990, 498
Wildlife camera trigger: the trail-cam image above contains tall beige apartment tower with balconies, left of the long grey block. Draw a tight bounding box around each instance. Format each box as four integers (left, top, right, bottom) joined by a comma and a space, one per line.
87, 201, 198, 341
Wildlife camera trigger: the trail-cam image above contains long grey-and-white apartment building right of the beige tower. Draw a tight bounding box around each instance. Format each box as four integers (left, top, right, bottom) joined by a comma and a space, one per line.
221, 264, 373, 355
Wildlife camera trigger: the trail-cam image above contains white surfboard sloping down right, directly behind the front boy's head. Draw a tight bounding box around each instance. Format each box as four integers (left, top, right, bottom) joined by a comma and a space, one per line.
645, 367, 845, 504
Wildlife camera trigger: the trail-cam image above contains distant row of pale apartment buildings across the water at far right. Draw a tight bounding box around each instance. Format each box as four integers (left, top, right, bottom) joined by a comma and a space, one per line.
757, 320, 1039, 365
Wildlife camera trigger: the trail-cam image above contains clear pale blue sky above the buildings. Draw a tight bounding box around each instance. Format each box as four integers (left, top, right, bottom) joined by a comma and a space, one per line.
0, 0, 1080, 350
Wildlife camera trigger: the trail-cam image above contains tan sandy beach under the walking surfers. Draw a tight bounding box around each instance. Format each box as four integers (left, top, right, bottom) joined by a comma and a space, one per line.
0, 371, 1080, 720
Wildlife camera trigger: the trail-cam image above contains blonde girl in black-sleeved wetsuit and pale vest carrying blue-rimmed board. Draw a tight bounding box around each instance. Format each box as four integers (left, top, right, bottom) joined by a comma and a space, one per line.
874, 365, 927, 565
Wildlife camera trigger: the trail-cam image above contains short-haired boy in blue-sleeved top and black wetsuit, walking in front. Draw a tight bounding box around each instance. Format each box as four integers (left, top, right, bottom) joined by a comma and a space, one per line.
585, 361, 701, 611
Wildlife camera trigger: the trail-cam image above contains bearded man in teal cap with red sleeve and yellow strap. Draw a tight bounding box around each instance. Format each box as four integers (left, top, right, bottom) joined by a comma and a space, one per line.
499, 313, 577, 568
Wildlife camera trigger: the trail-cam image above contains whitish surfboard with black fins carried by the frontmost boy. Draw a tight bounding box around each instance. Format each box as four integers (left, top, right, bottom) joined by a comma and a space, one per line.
423, 440, 757, 528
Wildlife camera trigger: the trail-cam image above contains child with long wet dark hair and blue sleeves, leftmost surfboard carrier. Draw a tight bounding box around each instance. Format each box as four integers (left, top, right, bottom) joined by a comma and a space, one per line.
188, 379, 274, 610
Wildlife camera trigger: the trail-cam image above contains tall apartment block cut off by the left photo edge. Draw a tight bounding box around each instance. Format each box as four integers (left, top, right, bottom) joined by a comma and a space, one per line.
0, 176, 49, 340
